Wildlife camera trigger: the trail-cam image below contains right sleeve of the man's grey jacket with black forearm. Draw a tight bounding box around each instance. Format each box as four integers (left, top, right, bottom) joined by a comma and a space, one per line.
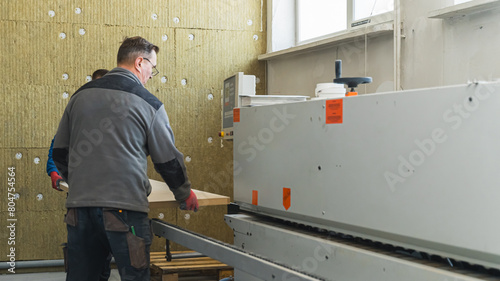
148, 105, 191, 202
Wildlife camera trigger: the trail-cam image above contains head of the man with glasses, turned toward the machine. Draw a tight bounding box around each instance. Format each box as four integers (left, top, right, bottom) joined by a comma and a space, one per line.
117, 36, 160, 85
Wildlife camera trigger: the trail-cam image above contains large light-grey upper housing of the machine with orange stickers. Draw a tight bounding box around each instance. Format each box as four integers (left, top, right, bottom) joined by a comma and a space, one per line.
234, 82, 500, 269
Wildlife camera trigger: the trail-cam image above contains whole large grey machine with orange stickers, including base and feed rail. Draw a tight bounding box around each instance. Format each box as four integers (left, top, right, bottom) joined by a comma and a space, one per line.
153, 63, 500, 281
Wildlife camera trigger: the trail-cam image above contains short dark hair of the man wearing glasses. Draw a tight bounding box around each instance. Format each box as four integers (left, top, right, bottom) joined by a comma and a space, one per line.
117, 36, 160, 64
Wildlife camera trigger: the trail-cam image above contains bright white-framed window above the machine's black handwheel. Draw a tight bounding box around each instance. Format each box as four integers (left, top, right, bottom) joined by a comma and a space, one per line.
295, 0, 392, 45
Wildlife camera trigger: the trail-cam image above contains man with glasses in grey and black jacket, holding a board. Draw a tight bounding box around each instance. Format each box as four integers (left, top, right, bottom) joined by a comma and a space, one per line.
53, 37, 198, 281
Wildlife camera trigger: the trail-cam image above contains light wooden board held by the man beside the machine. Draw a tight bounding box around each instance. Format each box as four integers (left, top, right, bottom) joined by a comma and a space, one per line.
59, 179, 230, 208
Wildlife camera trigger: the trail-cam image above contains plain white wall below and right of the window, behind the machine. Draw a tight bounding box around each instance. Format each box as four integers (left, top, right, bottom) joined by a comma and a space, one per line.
267, 0, 500, 96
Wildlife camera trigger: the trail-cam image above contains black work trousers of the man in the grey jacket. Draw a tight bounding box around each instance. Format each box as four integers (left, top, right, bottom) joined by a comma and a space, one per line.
65, 207, 152, 281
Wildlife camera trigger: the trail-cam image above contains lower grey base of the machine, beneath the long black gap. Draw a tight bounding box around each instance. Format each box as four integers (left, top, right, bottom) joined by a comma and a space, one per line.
225, 214, 492, 281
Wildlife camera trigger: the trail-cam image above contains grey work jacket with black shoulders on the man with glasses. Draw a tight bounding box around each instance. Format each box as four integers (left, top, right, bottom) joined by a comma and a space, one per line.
53, 68, 191, 212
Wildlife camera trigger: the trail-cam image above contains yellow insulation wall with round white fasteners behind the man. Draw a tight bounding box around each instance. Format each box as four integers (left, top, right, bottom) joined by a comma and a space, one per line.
0, 0, 267, 261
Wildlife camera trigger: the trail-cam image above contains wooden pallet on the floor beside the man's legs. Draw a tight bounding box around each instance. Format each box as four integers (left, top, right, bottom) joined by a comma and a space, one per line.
151, 252, 234, 281
